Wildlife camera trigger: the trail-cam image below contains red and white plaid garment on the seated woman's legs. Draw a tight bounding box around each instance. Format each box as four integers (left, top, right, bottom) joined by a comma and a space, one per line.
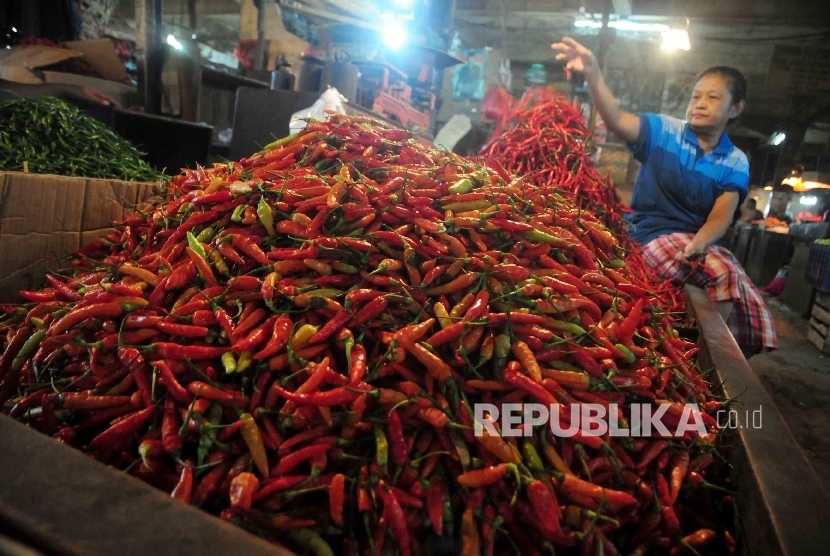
643, 233, 778, 351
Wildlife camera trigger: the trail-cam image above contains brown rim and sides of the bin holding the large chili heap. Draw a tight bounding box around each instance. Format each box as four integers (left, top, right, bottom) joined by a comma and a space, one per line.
0, 287, 830, 556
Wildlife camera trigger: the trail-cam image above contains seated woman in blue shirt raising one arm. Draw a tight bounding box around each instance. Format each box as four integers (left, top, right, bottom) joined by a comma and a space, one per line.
552, 37, 778, 356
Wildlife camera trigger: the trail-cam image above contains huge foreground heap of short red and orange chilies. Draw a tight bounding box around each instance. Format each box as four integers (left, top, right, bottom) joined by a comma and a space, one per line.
0, 115, 731, 555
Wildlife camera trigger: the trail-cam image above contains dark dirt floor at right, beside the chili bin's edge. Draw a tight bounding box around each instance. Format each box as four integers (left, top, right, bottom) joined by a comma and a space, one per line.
749, 295, 830, 492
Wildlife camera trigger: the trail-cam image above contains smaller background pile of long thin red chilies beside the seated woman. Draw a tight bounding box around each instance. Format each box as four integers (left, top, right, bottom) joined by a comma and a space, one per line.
480, 88, 685, 313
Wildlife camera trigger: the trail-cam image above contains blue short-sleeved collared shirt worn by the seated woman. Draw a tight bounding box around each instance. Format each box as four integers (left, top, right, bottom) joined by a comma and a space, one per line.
631, 114, 749, 244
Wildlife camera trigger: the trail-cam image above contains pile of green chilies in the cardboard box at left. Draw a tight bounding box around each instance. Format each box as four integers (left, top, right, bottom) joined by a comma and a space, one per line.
0, 97, 160, 181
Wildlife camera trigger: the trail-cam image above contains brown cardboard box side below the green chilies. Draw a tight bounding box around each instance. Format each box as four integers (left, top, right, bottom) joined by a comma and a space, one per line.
0, 172, 157, 303
